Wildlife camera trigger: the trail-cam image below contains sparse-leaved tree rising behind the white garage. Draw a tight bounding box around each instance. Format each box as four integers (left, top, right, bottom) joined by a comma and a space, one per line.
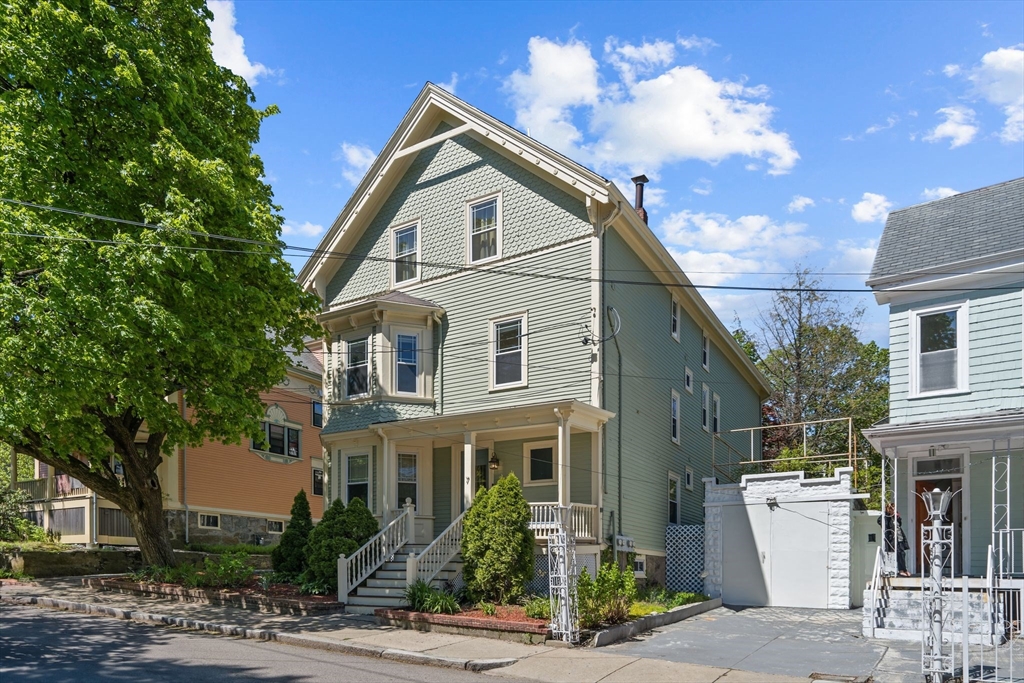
733, 267, 889, 491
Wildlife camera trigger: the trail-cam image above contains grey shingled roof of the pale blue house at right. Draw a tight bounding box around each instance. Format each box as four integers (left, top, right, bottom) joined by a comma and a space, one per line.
867, 178, 1024, 287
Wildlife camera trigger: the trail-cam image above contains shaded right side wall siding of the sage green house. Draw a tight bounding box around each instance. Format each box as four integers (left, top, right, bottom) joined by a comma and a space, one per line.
603, 230, 760, 551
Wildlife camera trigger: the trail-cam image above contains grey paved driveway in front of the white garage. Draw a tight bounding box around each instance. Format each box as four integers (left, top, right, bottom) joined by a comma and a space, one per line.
602, 607, 921, 683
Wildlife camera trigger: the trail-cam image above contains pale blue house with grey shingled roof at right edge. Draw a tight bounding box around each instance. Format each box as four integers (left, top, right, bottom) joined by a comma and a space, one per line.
865, 178, 1024, 577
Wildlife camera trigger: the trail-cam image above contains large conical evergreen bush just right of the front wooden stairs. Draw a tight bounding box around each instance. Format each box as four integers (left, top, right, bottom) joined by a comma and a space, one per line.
462, 474, 534, 605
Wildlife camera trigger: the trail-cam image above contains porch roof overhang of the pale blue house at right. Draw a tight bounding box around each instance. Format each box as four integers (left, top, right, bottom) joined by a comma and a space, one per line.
863, 411, 1024, 458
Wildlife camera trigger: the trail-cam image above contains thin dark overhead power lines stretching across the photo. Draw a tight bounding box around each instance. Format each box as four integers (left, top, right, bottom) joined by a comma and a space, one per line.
0, 198, 1019, 294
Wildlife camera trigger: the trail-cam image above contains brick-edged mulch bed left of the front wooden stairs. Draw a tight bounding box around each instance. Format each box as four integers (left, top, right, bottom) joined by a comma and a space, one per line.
82, 579, 345, 614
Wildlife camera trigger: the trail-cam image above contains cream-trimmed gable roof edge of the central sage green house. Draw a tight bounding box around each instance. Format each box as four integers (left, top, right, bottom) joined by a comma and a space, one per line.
298, 83, 771, 399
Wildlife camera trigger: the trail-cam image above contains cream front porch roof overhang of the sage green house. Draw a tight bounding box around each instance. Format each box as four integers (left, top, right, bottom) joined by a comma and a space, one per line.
369, 399, 615, 439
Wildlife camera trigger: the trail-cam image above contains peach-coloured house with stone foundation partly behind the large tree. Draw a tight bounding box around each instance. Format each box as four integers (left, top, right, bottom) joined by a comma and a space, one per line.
17, 341, 325, 546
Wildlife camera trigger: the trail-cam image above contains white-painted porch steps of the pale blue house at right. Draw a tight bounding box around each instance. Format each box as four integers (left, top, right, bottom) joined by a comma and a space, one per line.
862, 579, 1005, 644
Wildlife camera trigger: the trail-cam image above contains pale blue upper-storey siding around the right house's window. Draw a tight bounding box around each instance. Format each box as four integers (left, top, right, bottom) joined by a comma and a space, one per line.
889, 288, 1024, 424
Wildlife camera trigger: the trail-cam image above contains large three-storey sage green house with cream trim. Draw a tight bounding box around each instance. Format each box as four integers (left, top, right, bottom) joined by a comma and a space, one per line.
300, 84, 768, 604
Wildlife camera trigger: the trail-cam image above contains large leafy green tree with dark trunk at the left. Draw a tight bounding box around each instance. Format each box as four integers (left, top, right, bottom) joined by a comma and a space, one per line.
0, 0, 316, 564
